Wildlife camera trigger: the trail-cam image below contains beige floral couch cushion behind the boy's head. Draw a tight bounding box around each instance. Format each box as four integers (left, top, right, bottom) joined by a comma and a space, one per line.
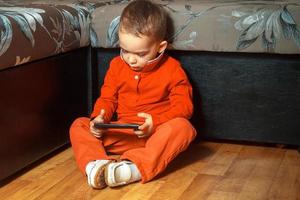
89, 0, 300, 54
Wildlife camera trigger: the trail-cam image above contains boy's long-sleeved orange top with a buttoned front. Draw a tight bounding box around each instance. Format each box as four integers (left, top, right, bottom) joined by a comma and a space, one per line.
91, 55, 193, 131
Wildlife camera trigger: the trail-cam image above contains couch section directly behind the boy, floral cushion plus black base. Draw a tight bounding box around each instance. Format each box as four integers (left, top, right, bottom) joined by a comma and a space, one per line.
91, 0, 300, 146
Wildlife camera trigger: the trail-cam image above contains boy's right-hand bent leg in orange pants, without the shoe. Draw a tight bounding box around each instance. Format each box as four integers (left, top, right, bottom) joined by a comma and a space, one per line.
121, 118, 196, 183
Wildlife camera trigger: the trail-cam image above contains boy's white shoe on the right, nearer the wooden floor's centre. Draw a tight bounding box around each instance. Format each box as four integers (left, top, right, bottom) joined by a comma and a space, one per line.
105, 161, 141, 187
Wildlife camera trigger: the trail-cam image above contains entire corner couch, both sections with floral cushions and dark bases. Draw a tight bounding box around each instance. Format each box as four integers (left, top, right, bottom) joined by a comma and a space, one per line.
0, 0, 300, 180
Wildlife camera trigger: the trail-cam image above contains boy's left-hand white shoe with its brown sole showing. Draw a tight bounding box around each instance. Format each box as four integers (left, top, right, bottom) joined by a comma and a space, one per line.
85, 160, 112, 189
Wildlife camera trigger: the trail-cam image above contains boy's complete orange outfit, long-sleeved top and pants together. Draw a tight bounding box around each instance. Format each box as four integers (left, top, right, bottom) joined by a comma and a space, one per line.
70, 55, 196, 183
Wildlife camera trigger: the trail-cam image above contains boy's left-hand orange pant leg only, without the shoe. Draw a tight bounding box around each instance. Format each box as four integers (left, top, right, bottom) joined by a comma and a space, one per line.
70, 117, 145, 174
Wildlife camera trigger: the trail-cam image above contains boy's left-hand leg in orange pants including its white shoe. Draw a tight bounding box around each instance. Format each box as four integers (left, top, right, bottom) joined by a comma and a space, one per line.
70, 117, 145, 189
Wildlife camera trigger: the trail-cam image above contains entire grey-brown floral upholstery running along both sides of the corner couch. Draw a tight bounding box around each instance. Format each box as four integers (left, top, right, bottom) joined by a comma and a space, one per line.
0, 0, 300, 69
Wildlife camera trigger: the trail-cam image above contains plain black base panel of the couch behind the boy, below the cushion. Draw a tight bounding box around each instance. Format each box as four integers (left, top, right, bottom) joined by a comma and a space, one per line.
95, 49, 300, 146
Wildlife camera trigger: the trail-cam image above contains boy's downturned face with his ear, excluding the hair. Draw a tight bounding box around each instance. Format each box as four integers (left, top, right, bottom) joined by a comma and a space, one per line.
119, 30, 167, 71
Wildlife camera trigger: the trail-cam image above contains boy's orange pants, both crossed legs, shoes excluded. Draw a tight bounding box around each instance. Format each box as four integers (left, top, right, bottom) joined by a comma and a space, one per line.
70, 117, 196, 183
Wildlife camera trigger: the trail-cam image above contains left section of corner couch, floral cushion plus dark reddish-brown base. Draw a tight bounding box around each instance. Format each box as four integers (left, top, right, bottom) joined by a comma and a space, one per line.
0, 1, 90, 180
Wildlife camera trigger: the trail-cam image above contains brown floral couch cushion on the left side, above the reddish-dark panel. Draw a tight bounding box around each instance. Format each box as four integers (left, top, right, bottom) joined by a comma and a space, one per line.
0, 0, 90, 69
